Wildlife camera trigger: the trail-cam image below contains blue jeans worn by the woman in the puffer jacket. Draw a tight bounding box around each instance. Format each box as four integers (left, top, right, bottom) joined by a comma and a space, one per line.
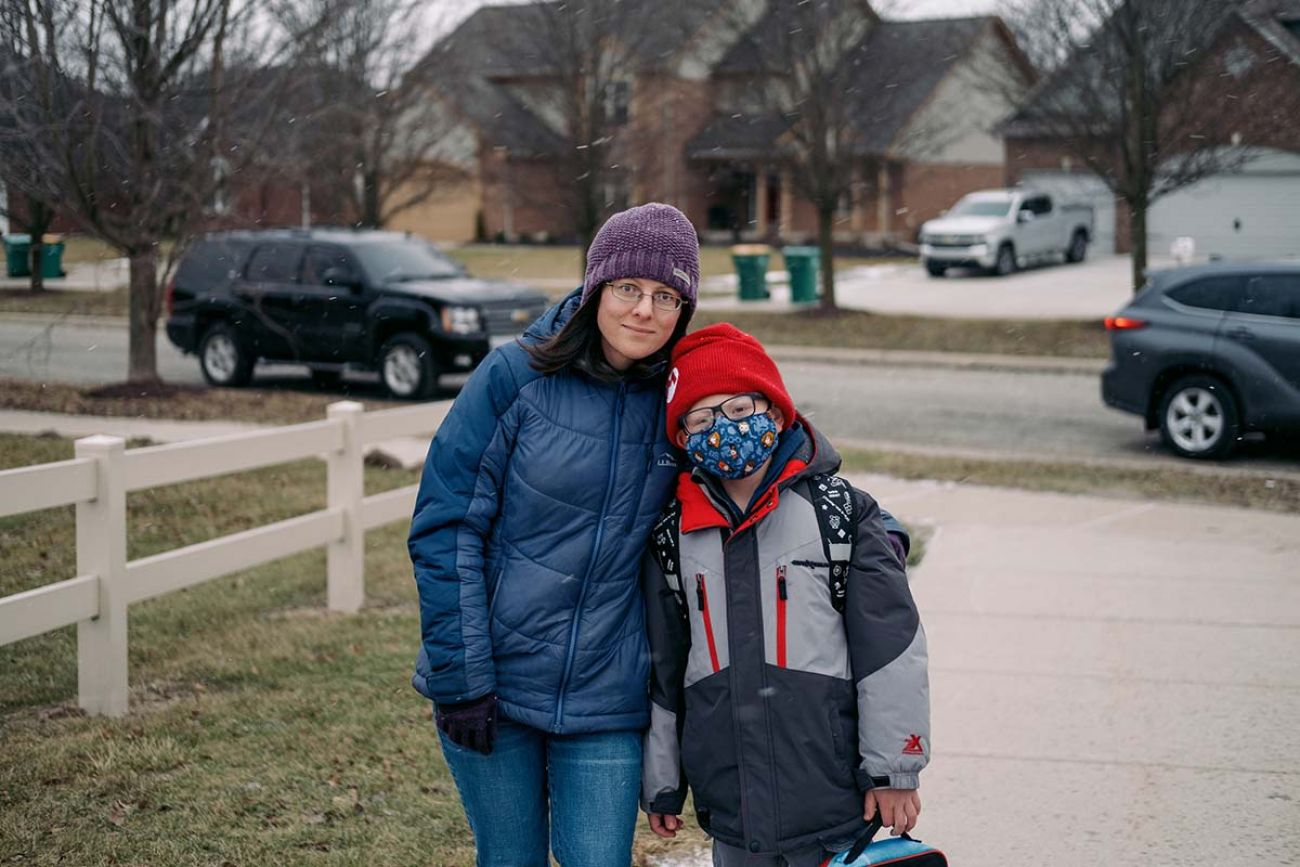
438, 720, 641, 867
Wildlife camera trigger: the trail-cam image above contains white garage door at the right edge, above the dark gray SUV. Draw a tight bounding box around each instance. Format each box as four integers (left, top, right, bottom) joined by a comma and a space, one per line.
1147, 151, 1300, 259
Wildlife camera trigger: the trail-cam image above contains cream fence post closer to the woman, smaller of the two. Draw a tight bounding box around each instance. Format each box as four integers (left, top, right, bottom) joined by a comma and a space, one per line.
326, 400, 365, 614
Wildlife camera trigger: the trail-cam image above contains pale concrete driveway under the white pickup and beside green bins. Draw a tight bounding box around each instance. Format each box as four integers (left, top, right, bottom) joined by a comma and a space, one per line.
699, 256, 1173, 320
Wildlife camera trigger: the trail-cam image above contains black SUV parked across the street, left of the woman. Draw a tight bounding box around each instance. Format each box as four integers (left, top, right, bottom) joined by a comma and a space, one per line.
166, 229, 547, 398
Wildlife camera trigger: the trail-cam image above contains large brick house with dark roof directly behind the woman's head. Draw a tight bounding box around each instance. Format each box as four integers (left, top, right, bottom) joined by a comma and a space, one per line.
395, 0, 1030, 246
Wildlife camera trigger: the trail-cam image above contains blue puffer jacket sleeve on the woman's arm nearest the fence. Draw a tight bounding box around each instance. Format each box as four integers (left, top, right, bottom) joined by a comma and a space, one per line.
407, 347, 519, 705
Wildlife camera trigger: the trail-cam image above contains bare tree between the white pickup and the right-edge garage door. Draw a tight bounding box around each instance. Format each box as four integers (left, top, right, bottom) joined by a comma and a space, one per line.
1005, 0, 1300, 290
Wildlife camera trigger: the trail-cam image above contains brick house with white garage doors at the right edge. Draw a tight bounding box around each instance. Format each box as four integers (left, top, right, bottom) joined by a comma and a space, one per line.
1002, 0, 1300, 257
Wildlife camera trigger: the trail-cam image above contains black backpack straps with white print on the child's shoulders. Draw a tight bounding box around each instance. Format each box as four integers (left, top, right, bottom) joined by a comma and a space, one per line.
650, 473, 858, 614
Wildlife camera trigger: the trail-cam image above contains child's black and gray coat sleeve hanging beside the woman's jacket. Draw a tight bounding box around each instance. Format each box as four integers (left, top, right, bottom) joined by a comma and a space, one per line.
641, 551, 690, 815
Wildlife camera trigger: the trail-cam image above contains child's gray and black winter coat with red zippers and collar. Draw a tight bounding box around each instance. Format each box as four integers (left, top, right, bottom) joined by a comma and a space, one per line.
642, 422, 930, 854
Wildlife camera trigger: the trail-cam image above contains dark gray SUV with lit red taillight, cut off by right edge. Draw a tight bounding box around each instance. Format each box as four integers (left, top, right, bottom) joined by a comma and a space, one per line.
1101, 263, 1300, 458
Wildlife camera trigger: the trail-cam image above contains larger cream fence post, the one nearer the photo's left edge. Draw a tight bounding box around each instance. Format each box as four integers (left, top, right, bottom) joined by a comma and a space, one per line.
75, 437, 127, 716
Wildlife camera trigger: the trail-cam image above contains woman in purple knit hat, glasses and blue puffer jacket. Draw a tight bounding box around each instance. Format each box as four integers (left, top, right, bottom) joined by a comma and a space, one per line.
408, 204, 699, 867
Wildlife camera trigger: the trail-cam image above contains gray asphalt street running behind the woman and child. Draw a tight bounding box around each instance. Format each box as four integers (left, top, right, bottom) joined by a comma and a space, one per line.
0, 321, 1300, 471
